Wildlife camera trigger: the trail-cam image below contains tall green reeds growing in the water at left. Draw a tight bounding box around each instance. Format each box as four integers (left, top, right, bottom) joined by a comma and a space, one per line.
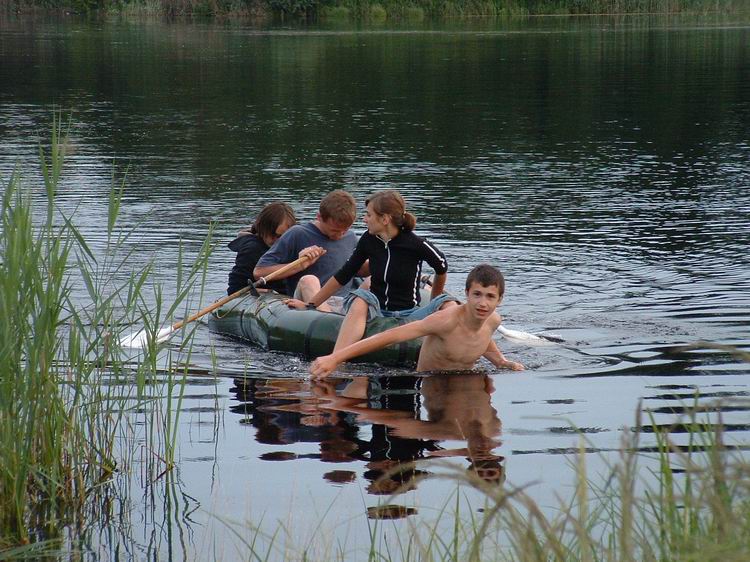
0, 117, 216, 557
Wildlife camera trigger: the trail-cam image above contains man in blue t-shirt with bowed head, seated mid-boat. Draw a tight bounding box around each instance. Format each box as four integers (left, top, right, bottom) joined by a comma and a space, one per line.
253, 190, 357, 302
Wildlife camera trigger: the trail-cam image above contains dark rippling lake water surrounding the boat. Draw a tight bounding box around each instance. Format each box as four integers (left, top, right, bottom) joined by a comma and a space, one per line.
0, 10, 750, 560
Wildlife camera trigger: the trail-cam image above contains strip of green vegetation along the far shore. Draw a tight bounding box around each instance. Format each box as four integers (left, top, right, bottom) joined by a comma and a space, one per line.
6, 0, 747, 23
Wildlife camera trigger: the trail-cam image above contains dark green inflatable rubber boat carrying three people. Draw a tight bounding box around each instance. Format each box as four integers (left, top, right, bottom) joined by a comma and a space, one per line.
208, 293, 421, 365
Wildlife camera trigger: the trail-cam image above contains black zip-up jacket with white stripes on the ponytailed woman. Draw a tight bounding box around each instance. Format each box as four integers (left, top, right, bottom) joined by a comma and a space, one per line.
334, 231, 448, 310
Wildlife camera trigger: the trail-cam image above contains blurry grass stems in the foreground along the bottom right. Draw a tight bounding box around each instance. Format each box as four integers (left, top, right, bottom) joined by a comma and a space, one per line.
220, 394, 750, 562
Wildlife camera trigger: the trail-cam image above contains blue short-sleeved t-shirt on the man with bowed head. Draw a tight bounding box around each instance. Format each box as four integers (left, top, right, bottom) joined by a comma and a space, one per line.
256, 222, 357, 296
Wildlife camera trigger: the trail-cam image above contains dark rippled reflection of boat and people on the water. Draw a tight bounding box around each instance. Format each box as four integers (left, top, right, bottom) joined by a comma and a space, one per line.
231, 373, 503, 495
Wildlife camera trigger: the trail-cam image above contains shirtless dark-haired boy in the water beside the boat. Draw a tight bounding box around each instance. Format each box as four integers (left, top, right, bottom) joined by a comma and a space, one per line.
310, 264, 523, 378
